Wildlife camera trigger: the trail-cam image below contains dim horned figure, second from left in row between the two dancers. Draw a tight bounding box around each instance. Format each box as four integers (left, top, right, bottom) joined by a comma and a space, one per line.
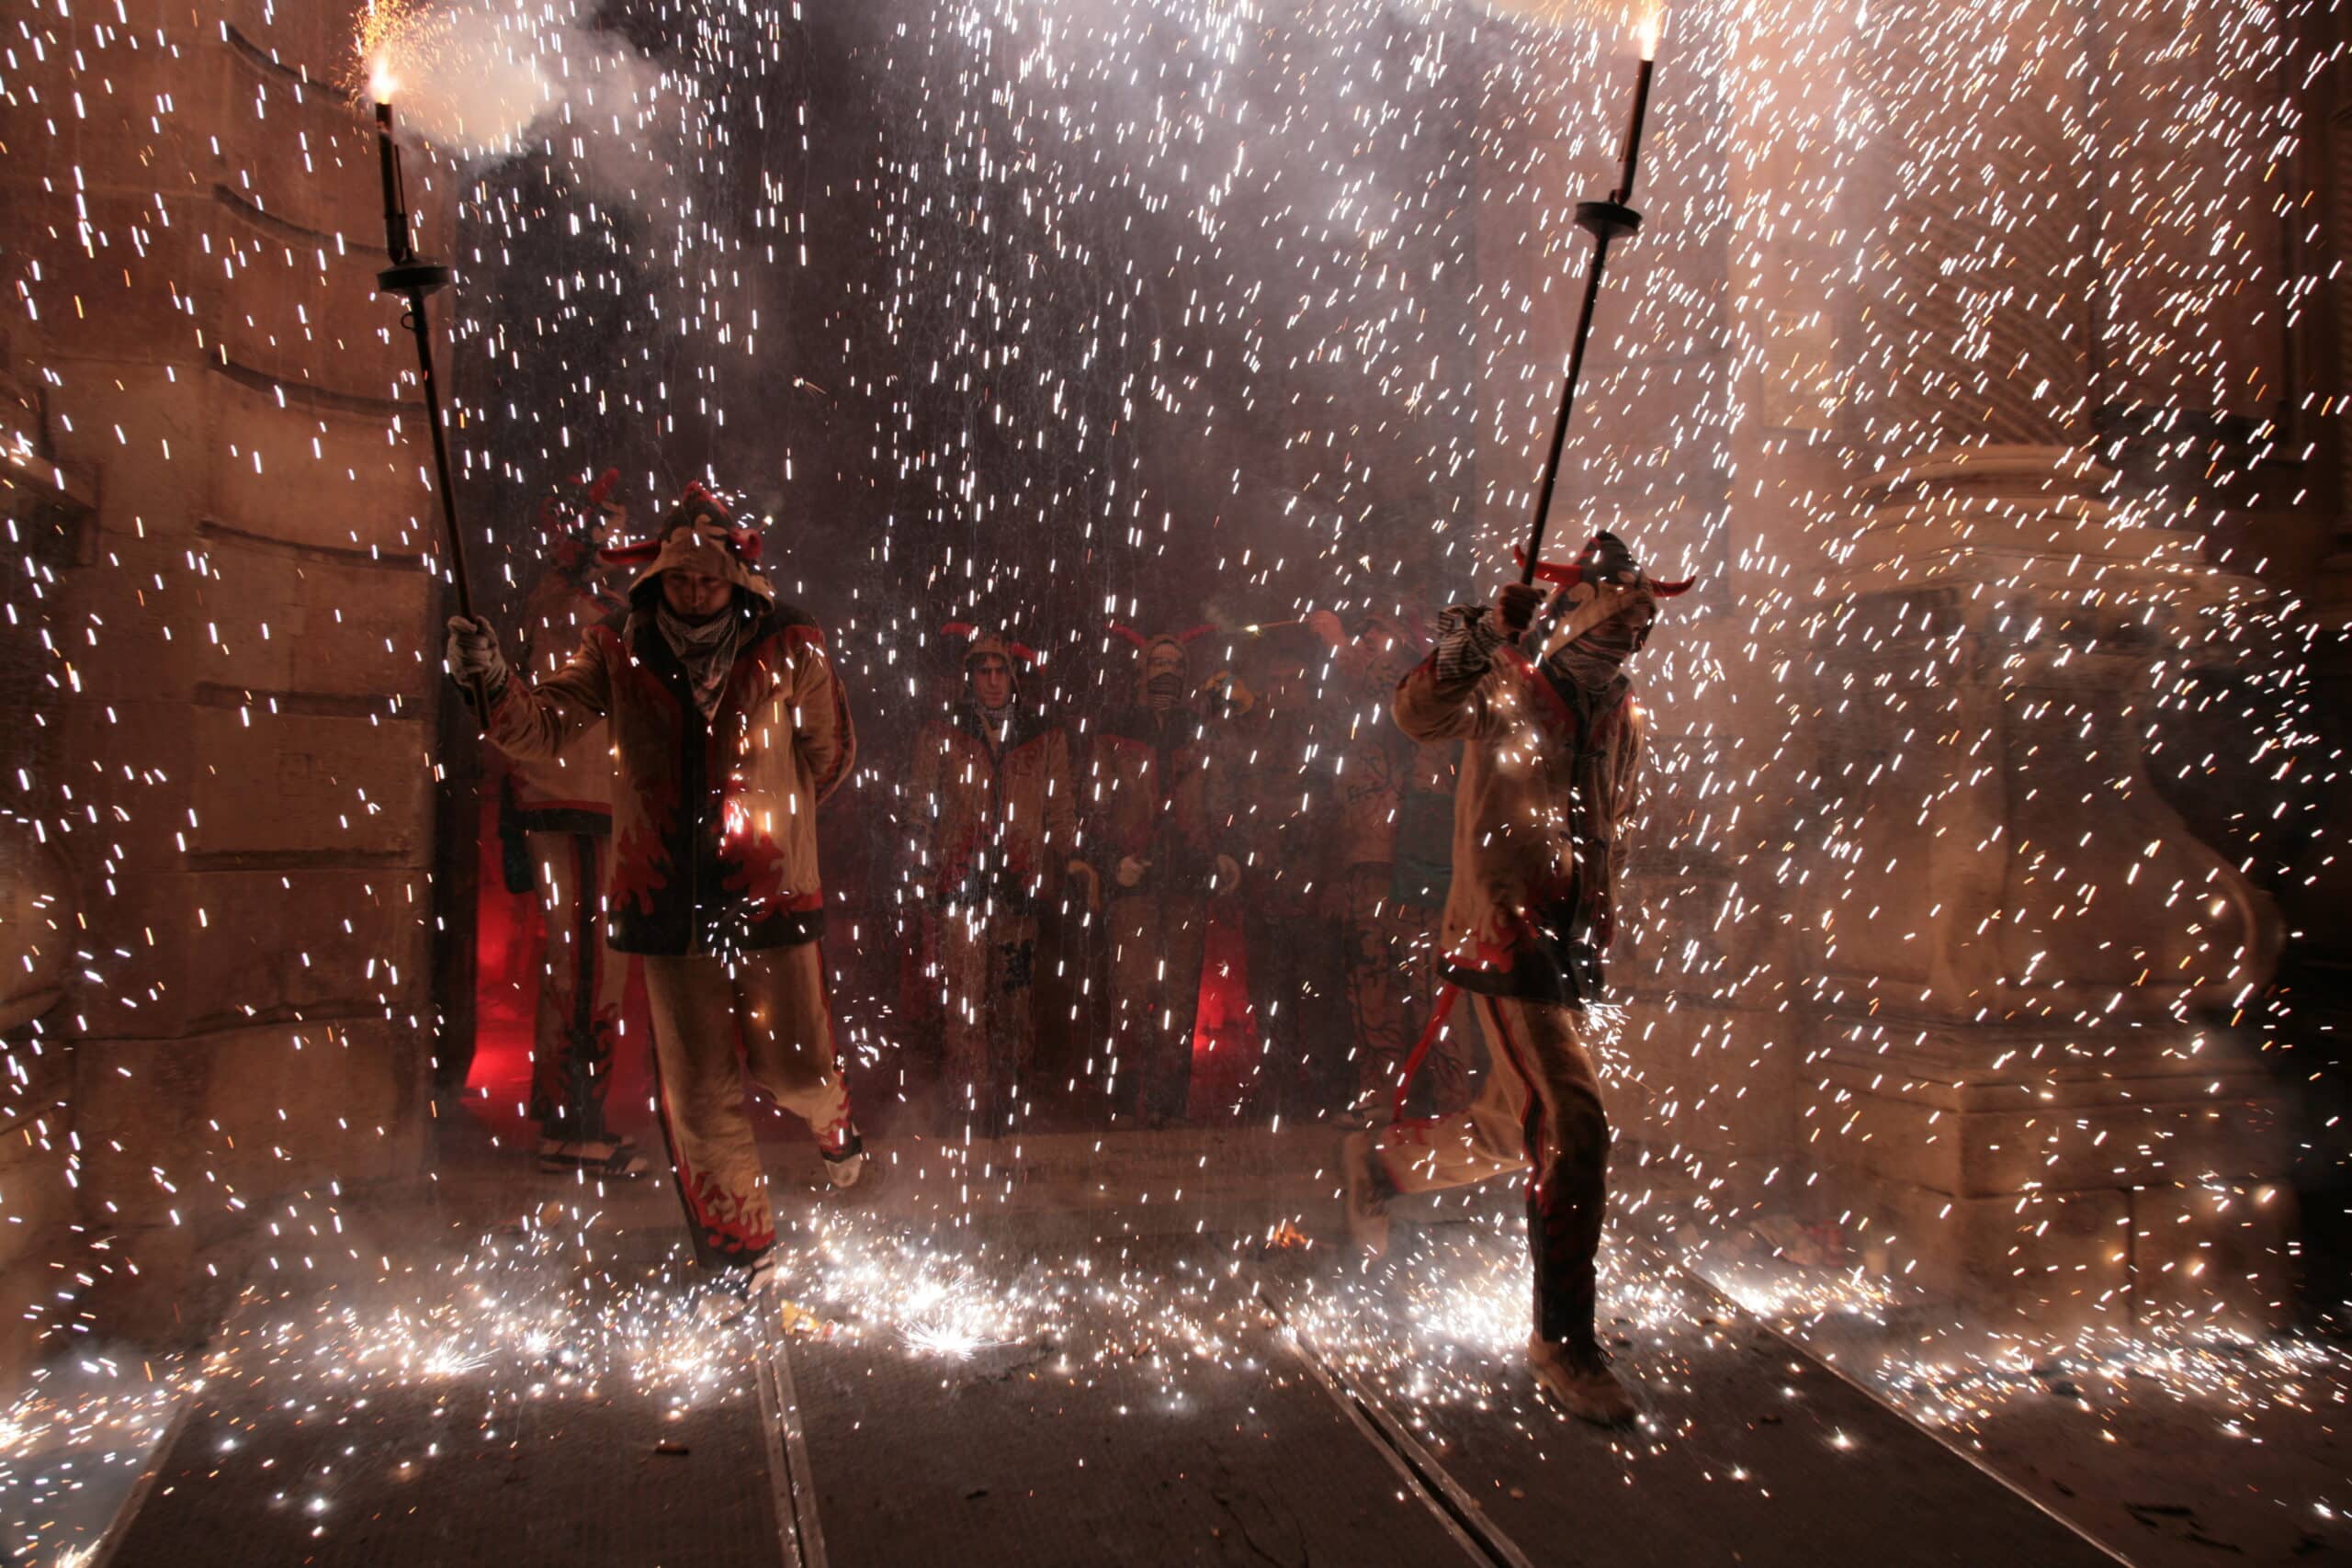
1091, 626, 1242, 1126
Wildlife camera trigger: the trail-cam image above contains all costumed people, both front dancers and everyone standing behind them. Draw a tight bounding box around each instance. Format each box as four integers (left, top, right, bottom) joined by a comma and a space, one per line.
447, 482, 1687, 1422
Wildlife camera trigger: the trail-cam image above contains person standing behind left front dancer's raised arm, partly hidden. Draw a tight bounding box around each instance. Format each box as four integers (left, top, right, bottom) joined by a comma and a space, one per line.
499, 470, 647, 1176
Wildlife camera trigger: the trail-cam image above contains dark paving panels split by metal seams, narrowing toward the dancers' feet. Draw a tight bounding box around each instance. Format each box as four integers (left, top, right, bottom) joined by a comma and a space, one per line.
78, 1220, 2105, 1568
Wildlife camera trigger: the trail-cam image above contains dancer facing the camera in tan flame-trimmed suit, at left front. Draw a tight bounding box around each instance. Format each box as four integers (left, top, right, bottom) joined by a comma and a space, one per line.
447, 484, 865, 1283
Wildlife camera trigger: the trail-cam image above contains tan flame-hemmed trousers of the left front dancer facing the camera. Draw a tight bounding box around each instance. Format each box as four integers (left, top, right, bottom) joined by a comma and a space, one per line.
644, 942, 849, 1265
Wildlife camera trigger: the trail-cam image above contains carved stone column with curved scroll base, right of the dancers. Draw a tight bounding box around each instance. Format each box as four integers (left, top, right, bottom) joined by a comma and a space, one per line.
1806, 5, 2293, 1328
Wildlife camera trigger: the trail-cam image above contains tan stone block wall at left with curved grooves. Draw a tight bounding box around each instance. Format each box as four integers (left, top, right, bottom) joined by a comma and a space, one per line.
0, 0, 447, 1359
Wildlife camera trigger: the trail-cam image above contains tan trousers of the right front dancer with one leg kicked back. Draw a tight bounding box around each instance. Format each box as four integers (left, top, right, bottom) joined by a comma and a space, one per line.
1376, 995, 1609, 1349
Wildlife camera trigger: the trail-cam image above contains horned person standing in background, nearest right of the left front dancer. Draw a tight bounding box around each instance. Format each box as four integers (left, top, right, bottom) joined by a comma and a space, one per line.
910, 621, 1093, 1134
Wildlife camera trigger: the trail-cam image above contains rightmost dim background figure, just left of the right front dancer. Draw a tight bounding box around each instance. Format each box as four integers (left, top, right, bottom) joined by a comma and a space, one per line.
1336, 614, 1470, 1126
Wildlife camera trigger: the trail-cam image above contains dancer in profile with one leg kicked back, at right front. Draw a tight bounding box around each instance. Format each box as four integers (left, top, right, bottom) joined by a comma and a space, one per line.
1343, 534, 1689, 1425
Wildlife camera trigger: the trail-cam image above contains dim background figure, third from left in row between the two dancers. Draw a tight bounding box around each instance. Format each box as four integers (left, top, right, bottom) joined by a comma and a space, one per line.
1216, 623, 1355, 1119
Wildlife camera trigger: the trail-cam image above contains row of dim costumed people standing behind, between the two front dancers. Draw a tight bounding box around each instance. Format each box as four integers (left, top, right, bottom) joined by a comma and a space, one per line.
906, 616, 1470, 1131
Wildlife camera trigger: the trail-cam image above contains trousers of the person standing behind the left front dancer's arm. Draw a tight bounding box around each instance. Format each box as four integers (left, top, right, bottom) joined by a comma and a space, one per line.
526, 832, 628, 1143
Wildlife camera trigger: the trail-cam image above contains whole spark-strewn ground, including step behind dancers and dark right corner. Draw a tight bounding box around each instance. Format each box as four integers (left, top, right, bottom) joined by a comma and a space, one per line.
17, 1114, 2345, 1568
